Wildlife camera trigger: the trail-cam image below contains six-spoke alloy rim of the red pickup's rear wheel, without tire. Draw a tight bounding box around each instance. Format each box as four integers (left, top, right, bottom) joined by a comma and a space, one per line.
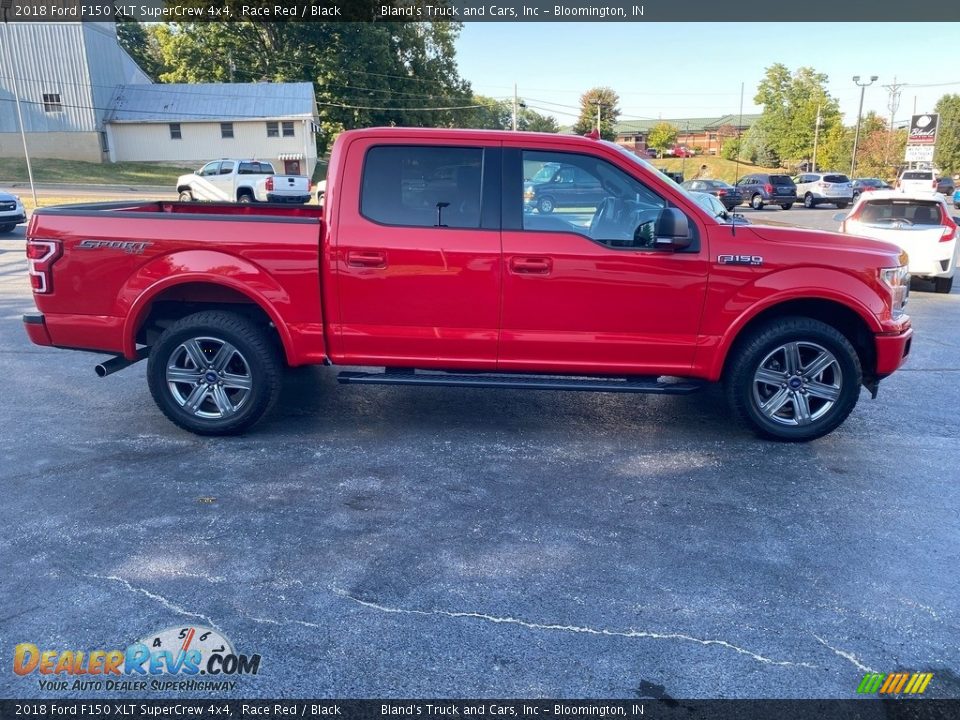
166, 337, 253, 420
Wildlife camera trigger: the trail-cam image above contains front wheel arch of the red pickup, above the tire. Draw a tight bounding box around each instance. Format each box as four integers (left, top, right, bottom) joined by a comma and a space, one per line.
710, 297, 880, 379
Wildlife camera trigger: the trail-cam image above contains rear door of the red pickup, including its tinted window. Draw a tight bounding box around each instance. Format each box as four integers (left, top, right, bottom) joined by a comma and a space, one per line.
328, 139, 501, 369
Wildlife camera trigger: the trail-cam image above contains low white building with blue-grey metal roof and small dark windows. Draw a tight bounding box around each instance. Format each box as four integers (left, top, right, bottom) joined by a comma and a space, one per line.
106, 83, 317, 175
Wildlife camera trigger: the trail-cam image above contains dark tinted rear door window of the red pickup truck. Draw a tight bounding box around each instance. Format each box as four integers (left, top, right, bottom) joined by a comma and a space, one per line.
360, 145, 483, 228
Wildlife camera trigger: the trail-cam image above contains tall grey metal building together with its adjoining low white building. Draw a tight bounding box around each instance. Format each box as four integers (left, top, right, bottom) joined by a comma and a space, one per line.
0, 22, 318, 179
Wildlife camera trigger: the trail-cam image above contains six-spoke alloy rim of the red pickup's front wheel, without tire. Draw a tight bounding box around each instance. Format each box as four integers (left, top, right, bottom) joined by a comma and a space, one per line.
753, 342, 843, 426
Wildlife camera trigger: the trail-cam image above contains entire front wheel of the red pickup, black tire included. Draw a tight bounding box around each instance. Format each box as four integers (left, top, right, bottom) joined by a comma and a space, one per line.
725, 317, 862, 442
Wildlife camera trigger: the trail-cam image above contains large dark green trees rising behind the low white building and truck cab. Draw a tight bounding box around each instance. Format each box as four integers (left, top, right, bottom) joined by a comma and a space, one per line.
140, 14, 476, 150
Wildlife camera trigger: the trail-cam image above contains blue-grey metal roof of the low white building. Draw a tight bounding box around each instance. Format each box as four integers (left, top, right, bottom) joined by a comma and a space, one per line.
105, 83, 316, 123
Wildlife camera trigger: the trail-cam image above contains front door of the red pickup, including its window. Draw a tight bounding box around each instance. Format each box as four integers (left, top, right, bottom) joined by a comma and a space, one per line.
498, 147, 708, 375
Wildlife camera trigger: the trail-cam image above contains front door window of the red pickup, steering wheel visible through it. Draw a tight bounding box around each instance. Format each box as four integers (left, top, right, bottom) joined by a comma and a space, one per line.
522, 151, 667, 250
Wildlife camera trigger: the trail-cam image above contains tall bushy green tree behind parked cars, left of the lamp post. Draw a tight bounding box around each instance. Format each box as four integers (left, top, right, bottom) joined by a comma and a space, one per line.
750, 63, 841, 165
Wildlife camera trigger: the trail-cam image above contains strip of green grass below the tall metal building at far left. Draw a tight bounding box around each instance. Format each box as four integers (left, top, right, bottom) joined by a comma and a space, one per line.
0, 158, 196, 185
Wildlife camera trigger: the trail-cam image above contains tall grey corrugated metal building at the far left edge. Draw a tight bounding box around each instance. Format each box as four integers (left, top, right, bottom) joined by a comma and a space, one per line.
0, 22, 150, 163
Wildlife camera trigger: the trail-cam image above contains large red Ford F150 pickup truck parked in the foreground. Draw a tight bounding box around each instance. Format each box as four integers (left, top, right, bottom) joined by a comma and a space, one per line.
18, 128, 912, 440
